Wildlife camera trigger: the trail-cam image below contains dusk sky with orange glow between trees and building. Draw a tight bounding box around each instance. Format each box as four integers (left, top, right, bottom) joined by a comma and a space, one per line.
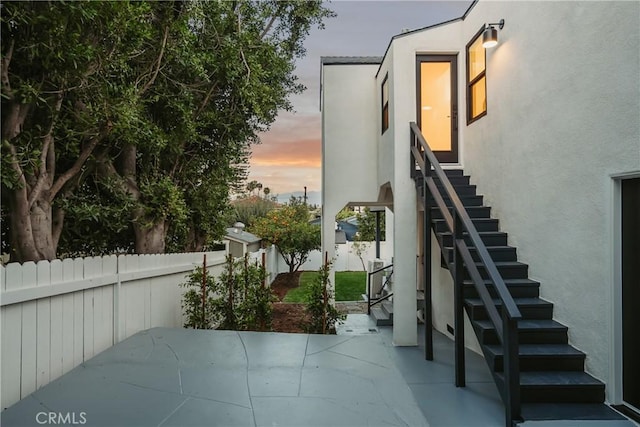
249, 0, 472, 194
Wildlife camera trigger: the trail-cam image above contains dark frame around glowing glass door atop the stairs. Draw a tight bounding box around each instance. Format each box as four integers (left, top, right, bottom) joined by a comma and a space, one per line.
416, 53, 460, 164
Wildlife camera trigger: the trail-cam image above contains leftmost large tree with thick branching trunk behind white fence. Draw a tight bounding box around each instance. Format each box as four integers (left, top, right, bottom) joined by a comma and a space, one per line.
0, 2, 154, 261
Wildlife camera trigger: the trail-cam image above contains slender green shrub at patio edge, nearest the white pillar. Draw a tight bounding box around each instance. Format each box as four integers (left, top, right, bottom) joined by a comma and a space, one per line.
303, 261, 346, 334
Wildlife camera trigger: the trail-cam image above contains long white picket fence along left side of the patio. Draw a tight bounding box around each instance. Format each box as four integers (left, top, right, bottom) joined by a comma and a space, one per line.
0, 251, 225, 409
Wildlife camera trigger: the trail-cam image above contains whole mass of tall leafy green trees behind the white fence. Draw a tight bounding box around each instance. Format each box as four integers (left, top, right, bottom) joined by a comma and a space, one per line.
2, 1, 331, 261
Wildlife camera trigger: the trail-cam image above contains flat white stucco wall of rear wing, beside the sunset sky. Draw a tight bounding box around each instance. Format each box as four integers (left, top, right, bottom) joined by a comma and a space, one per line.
322, 64, 379, 283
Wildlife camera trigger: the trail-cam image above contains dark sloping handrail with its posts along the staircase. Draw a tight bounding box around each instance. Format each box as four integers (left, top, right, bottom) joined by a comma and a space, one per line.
409, 122, 522, 425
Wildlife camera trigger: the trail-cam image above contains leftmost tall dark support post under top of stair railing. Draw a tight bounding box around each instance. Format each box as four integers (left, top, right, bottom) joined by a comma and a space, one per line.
422, 151, 433, 360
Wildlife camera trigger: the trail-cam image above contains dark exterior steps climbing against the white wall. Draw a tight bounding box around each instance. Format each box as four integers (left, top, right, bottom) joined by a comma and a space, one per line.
416, 170, 625, 421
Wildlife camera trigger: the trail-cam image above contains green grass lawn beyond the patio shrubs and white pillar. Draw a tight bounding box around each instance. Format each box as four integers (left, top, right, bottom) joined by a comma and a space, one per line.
283, 271, 367, 303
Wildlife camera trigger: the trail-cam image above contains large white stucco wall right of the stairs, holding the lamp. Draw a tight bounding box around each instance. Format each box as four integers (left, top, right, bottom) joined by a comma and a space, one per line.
456, 2, 640, 397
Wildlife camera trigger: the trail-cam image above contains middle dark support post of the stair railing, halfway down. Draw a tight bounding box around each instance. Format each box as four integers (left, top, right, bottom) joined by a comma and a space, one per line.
452, 208, 466, 387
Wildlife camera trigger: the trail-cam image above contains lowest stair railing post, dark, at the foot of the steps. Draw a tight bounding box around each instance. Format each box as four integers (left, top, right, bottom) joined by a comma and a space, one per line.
502, 306, 520, 427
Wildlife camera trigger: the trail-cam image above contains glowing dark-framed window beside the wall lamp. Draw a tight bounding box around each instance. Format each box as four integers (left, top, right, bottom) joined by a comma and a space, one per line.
467, 26, 487, 124
